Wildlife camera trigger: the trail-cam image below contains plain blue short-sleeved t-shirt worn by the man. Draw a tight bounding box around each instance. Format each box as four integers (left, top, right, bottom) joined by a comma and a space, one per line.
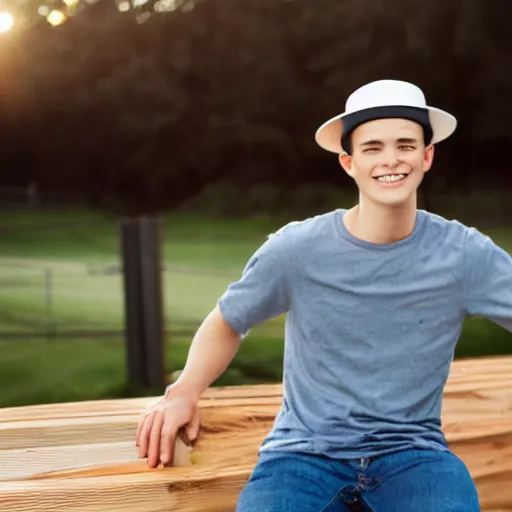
219, 209, 512, 458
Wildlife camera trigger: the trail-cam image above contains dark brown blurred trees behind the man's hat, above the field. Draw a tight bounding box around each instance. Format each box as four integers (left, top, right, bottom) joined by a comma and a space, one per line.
0, 0, 512, 211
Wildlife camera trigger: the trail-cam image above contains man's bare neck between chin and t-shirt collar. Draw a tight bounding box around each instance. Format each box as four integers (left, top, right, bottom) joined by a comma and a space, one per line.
344, 197, 417, 244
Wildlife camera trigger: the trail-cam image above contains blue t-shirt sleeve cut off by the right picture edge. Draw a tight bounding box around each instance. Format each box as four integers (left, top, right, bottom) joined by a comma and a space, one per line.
464, 228, 512, 332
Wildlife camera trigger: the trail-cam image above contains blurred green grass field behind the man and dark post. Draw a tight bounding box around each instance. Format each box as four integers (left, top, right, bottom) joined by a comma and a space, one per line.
0, 211, 512, 406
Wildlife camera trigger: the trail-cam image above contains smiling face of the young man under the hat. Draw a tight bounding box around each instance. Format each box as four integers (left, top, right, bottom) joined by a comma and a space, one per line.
340, 119, 434, 206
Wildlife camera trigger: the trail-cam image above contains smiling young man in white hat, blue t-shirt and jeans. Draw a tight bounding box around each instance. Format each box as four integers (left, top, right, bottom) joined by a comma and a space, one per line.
137, 80, 512, 512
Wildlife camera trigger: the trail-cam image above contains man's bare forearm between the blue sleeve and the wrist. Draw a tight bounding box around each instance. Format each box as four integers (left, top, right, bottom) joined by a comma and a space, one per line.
169, 307, 240, 399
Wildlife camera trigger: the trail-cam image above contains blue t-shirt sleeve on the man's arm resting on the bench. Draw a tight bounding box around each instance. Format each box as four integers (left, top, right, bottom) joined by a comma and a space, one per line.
218, 234, 290, 337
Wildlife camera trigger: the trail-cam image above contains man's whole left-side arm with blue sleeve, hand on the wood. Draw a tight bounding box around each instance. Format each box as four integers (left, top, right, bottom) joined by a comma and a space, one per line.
136, 235, 290, 467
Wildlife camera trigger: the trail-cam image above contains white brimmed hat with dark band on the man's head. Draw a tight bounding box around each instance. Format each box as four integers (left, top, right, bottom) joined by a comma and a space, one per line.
315, 80, 457, 154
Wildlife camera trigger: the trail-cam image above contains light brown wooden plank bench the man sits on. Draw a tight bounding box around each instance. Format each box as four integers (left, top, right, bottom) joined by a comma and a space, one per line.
0, 357, 512, 512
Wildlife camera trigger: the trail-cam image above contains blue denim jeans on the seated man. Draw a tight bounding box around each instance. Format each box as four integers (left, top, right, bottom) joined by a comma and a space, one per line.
236, 449, 480, 512
